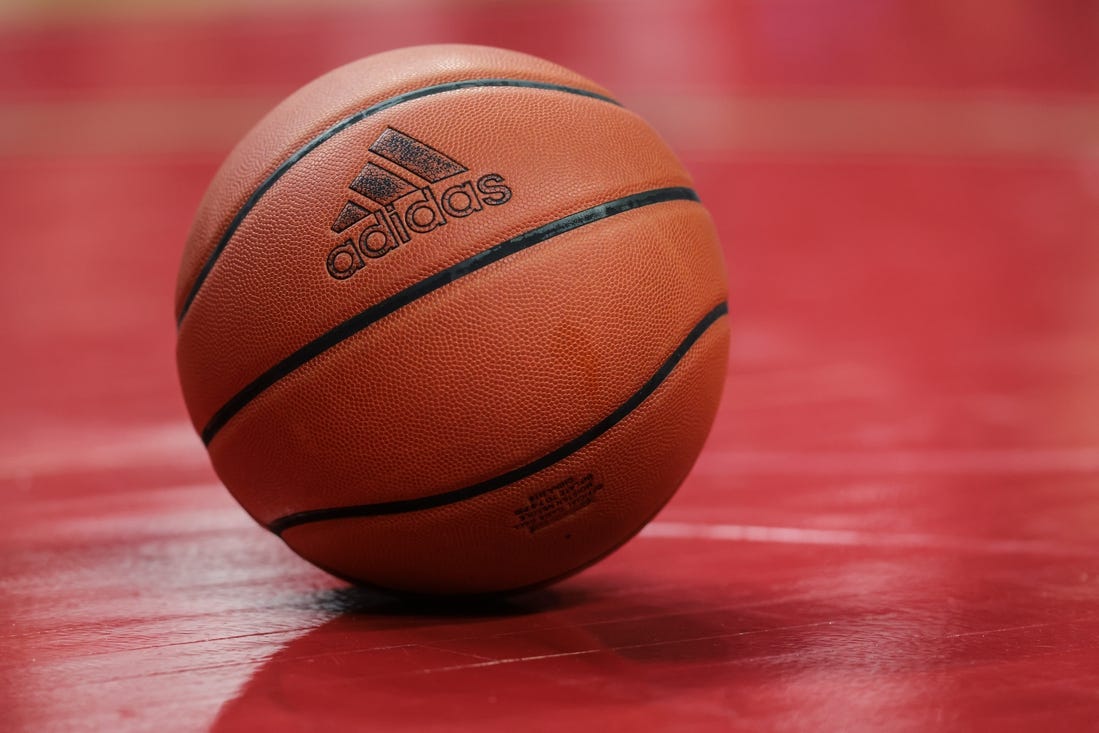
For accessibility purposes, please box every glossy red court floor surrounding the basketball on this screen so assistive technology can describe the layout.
[0,0,1099,732]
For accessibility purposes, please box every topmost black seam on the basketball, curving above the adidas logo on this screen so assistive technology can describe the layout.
[176,79,621,325]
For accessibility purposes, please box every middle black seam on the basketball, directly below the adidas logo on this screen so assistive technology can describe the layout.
[202,187,699,445]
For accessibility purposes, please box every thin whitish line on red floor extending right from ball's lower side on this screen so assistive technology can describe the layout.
[641,522,1099,557]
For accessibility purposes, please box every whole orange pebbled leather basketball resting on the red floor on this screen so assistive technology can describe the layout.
[176,45,729,593]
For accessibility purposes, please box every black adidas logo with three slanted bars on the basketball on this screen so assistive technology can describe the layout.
[328,127,511,280]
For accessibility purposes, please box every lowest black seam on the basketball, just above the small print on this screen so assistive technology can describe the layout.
[267,301,729,534]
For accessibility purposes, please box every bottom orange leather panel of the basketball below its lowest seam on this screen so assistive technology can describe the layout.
[284,319,729,595]
